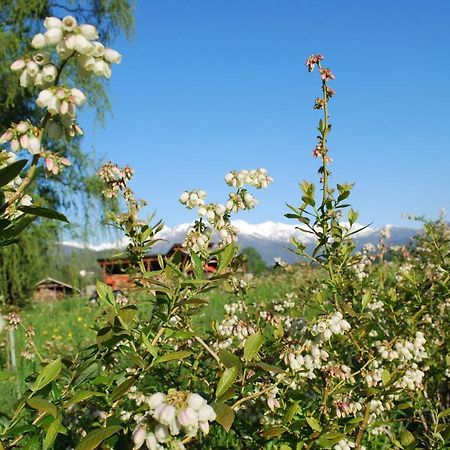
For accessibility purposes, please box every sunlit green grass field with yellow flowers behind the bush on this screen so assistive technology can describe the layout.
[0,272,310,414]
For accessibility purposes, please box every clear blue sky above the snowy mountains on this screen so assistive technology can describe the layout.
[81,0,450,226]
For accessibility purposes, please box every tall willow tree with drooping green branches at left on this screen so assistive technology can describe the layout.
[0,0,134,303]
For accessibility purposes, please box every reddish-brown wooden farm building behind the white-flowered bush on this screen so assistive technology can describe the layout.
[97,244,217,289]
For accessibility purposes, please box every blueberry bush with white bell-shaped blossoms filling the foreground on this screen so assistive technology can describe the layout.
[0,17,450,450]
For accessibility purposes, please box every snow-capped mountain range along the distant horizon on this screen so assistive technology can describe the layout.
[63,220,420,264]
